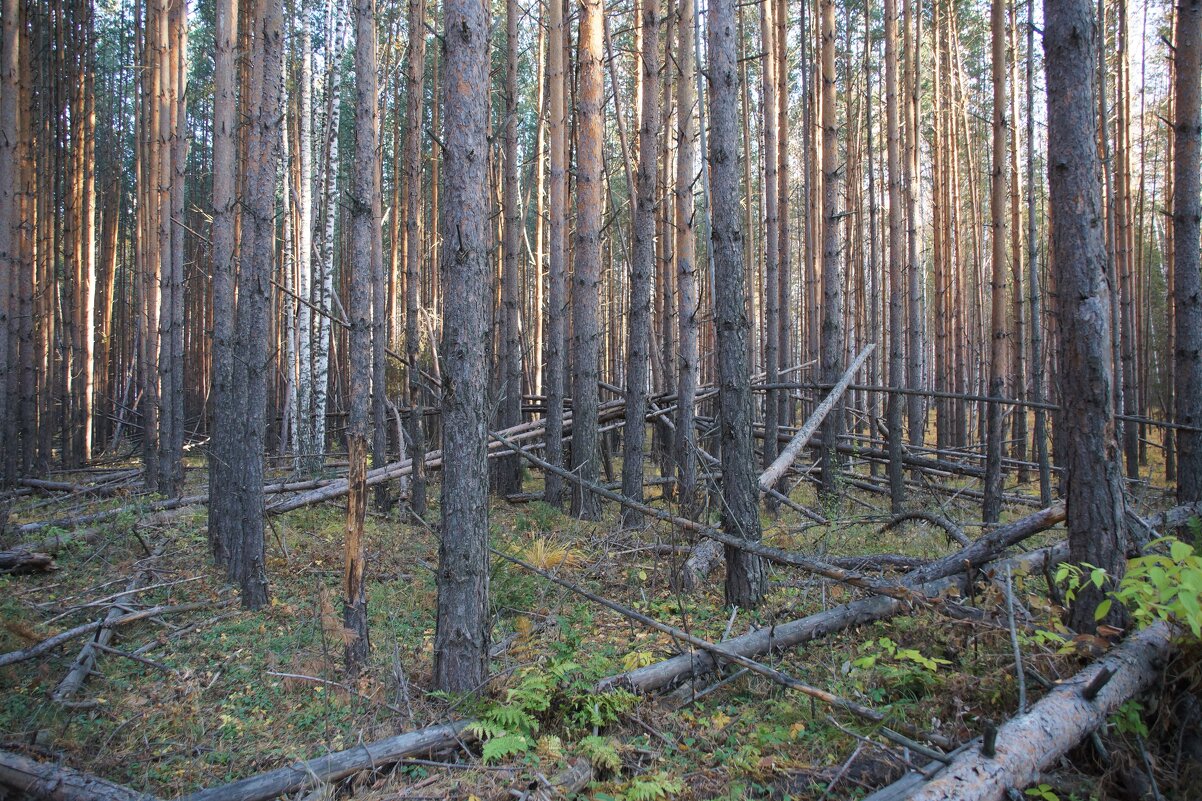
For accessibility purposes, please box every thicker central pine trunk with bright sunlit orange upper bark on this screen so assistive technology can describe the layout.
[571,0,605,520]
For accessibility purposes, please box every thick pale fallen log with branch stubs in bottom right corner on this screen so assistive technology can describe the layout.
[870,621,1172,801]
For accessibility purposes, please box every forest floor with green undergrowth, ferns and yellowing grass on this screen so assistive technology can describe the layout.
[0,445,1194,801]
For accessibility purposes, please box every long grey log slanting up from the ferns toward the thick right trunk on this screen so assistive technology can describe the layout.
[599,545,1069,693]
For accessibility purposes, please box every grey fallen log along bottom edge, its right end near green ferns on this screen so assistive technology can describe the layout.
[182,720,471,801]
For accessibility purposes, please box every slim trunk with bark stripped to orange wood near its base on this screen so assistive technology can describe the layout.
[343,0,385,677]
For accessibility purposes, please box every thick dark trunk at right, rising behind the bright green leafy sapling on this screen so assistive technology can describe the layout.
[1043,0,1126,631]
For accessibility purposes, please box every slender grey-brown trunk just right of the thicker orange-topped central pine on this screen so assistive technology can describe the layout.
[621,0,660,526]
